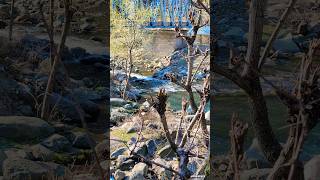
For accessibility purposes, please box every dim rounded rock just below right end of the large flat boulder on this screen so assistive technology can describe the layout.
[41,134,72,152]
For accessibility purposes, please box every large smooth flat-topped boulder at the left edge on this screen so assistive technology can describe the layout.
[0,116,54,141]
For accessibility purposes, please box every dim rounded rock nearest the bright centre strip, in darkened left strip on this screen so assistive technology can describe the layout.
[72,132,95,149]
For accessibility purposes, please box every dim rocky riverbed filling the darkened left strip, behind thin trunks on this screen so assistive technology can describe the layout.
[0,0,109,179]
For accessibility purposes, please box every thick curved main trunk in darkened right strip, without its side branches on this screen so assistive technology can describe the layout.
[242,0,281,163]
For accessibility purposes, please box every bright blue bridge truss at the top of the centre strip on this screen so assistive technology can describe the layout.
[112,0,191,28]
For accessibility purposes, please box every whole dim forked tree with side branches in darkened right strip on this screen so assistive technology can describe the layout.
[211,0,304,163]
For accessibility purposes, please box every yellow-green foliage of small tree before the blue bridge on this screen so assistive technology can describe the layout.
[110,0,151,67]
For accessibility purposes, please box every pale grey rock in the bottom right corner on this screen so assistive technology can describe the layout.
[303,155,320,180]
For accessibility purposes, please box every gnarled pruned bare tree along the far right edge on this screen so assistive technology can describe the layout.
[268,39,320,180]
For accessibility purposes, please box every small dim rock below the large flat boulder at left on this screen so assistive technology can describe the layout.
[31,144,54,161]
